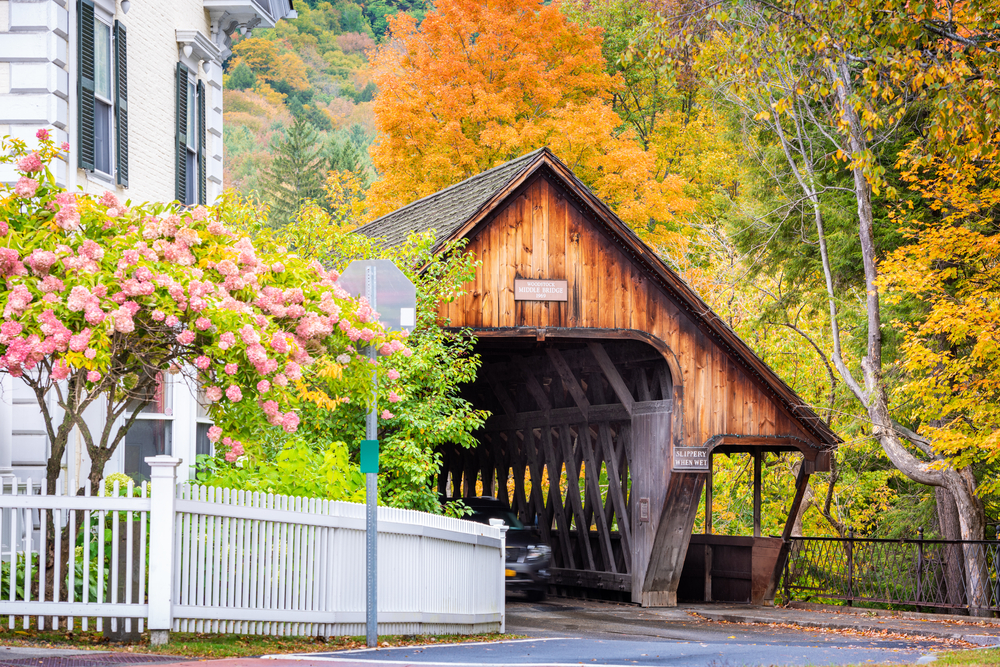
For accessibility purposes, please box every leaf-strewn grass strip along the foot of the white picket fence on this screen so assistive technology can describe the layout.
[0,628,522,658]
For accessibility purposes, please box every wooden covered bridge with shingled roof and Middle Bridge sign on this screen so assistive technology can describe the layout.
[359,149,837,606]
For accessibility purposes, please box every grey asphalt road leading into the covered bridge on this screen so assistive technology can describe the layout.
[262,598,955,667]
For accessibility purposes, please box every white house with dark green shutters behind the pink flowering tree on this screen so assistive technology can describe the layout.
[0,0,295,493]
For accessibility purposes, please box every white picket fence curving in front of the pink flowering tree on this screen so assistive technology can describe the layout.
[0,457,506,636]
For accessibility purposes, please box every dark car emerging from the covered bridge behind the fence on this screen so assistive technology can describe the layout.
[462,498,552,600]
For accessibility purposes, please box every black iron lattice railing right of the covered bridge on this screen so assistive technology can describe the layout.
[782,531,1000,612]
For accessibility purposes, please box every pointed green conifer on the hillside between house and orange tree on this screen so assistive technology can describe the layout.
[264,117,326,226]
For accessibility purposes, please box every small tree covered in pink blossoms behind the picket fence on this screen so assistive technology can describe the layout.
[0,130,408,493]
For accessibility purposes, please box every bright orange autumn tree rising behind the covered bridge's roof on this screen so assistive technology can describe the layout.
[369,0,694,251]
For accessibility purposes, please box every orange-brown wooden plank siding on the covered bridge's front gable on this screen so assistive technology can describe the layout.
[440,173,819,448]
